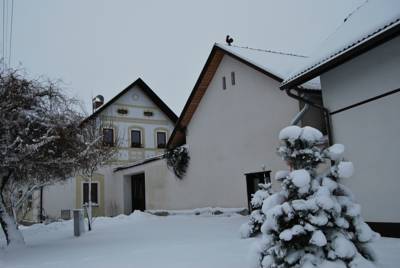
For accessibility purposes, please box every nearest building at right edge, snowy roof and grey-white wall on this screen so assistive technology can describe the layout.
[281,0,400,237]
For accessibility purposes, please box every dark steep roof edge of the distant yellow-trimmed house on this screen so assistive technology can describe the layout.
[83,78,178,123]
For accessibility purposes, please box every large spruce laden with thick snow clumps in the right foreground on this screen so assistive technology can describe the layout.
[255,126,379,268]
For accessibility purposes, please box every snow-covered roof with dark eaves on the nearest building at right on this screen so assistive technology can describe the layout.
[281,0,400,88]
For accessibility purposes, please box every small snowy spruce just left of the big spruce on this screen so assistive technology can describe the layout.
[240,183,272,238]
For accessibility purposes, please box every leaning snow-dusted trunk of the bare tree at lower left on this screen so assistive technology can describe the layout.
[0,193,25,247]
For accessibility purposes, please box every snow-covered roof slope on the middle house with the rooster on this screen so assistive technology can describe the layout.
[215,43,321,89]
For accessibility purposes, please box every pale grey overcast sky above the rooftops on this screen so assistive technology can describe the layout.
[3,0,365,115]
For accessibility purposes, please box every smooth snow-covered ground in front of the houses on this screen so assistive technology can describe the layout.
[0,213,400,268]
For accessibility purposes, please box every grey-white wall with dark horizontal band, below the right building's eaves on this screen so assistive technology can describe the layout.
[321,37,400,222]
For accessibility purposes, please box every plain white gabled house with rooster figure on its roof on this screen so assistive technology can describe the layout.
[114,44,324,213]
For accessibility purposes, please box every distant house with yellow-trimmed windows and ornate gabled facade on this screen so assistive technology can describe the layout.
[39,78,177,218]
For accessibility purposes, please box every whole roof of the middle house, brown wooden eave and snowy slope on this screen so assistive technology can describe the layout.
[167,44,320,148]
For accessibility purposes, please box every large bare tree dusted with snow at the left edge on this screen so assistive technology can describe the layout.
[0,70,95,246]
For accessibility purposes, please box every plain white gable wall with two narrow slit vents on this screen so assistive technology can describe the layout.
[185,56,299,207]
